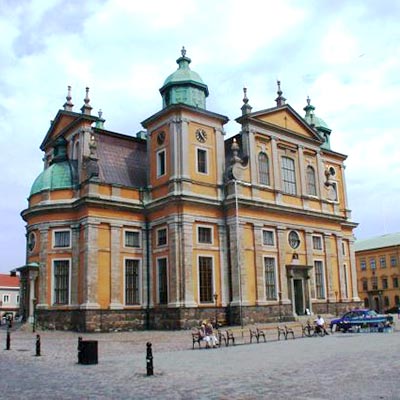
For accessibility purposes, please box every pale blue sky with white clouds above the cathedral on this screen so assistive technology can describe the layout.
[0,0,400,272]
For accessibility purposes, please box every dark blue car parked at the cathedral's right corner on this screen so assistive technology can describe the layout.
[330,309,393,332]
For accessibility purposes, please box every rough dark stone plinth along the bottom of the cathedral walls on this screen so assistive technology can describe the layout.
[36,302,361,332]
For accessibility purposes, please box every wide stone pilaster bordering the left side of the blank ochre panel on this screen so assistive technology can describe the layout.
[81,222,100,310]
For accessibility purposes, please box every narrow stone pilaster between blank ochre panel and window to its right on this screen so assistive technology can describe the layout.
[110,224,122,310]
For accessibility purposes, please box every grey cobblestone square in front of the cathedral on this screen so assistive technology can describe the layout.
[0,329,400,400]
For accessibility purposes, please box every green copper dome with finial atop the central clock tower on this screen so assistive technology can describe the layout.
[160,47,208,109]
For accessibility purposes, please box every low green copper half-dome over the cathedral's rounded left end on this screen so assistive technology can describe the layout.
[30,161,73,196]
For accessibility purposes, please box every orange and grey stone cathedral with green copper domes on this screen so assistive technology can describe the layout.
[19,49,360,331]
